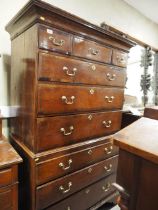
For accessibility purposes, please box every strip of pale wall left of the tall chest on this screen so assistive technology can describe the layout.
[0,0,27,106]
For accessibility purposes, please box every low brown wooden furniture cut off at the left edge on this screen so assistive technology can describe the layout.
[0,116,22,210]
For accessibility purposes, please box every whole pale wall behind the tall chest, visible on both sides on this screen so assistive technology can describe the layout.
[0,0,158,133]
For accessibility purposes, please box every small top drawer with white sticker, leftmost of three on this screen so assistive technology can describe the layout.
[39,26,72,54]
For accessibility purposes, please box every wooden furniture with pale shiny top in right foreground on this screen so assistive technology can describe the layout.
[114,116,158,210]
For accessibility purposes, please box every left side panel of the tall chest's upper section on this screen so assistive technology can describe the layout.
[10,25,37,150]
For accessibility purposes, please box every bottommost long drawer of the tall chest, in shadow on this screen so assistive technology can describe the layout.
[46,175,116,210]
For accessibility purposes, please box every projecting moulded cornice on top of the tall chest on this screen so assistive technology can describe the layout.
[6,0,134,51]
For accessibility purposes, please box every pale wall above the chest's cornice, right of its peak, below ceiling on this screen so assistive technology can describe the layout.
[44,0,158,49]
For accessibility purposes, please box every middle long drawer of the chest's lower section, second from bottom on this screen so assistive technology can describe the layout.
[36,156,118,210]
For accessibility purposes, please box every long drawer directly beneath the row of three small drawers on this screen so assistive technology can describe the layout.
[38,52,126,87]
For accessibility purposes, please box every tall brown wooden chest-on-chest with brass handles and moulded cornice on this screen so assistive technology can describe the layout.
[6,0,133,210]
